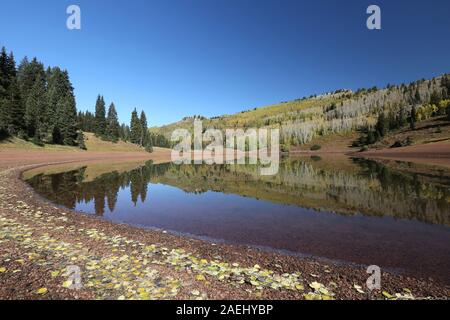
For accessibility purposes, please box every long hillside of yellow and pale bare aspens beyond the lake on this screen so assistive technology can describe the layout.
[150,75,450,149]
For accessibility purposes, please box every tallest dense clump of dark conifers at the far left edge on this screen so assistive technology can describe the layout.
[0,47,85,148]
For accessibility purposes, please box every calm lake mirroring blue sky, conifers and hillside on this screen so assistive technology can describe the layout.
[24,156,450,283]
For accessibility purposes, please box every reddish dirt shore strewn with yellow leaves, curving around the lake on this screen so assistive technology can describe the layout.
[0,151,450,299]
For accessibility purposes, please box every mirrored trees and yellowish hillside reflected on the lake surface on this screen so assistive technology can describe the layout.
[28,159,450,225]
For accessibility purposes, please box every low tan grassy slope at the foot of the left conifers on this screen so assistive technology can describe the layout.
[0,132,151,152]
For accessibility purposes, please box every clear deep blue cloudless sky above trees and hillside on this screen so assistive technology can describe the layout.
[0,0,450,126]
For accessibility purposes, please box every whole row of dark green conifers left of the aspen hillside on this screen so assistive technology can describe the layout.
[0,47,170,151]
